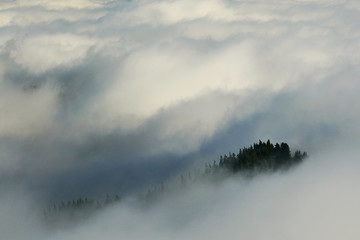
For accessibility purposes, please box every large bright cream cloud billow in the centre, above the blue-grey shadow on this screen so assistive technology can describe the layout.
[85,42,280,136]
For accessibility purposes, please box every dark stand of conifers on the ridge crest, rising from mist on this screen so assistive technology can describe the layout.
[176,140,307,188]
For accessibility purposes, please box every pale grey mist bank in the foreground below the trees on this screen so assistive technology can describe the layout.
[1,149,360,239]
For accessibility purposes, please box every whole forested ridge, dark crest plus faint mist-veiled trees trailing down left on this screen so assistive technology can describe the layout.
[44,140,307,224]
